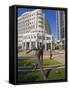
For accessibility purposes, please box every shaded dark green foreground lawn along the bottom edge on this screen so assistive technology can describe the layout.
[18,68,65,82]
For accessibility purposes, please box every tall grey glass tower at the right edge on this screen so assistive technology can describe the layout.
[57,11,65,48]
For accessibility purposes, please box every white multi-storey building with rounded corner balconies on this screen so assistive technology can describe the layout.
[18,9,52,49]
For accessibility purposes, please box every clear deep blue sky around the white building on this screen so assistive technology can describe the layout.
[18,8,56,38]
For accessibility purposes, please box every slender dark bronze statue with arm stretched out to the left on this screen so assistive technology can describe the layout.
[27,45,46,80]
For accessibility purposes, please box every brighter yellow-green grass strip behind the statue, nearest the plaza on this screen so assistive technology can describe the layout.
[17,59,61,66]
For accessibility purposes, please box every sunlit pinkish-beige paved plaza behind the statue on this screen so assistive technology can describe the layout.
[18,50,65,64]
